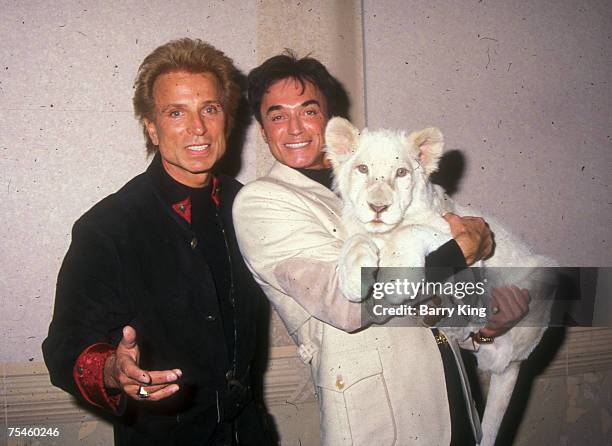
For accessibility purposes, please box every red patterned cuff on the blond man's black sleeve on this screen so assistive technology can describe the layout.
[72,343,121,413]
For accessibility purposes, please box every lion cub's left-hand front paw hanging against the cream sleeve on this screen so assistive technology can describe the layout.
[338,234,379,302]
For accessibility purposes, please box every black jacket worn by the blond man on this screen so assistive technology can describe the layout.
[43,157,265,444]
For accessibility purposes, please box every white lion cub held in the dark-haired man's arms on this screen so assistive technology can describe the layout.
[325,118,554,445]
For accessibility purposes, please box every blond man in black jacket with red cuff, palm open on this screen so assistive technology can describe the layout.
[43,39,266,446]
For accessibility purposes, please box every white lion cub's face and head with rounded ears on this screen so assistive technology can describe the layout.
[325,118,443,233]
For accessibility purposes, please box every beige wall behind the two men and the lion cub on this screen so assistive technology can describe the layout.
[0,0,612,445]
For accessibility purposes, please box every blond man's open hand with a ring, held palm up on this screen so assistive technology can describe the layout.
[104,325,182,401]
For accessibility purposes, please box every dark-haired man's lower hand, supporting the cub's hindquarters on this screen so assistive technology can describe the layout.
[479,285,531,338]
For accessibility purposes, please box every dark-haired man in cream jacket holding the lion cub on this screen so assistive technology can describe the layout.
[234,54,528,446]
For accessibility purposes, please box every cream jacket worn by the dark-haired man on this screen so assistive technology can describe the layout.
[233,162,478,446]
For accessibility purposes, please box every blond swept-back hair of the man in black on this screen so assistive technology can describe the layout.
[133,38,240,154]
